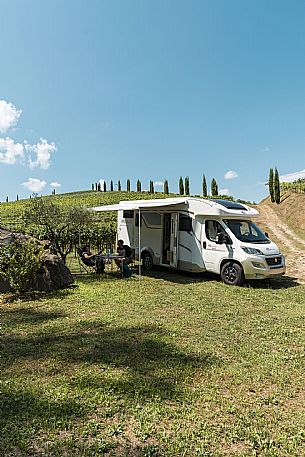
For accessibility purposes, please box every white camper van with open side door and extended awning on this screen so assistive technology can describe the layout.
[93,197,285,285]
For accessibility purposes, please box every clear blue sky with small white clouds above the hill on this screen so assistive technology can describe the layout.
[0,0,305,201]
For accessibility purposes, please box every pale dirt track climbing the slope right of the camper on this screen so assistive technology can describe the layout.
[257,203,305,283]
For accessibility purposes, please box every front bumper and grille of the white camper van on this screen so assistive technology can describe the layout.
[242,254,286,279]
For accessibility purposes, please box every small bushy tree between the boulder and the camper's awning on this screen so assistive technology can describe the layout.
[24,197,93,263]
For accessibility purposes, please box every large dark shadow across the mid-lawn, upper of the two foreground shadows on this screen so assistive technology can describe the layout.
[2,322,216,399]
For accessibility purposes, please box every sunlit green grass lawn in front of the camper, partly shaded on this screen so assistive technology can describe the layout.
[0,271,305,457]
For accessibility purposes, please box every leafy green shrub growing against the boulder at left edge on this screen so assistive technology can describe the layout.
[0,240,44,292]
